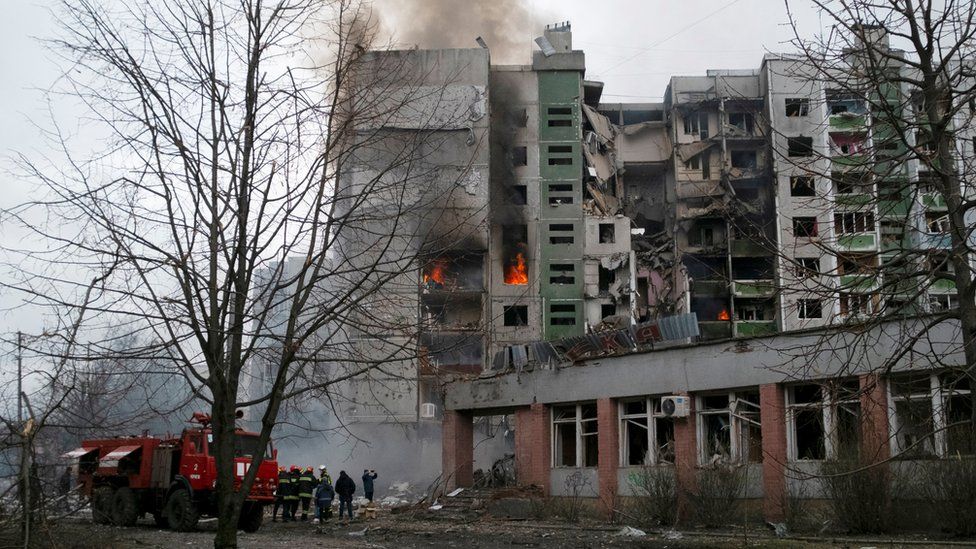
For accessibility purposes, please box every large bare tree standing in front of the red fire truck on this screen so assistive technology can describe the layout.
[6,0,487,547]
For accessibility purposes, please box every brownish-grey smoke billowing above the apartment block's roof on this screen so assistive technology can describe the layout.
[373,0,547,64]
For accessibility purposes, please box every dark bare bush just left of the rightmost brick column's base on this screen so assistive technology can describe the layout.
[820,458,891,534]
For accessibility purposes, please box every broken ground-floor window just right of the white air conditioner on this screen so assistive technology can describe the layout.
[697,391,762,465]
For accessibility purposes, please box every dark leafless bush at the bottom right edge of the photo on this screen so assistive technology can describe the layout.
[921,457,976,536]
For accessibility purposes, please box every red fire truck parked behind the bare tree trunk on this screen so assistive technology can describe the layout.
[65,412,278,532]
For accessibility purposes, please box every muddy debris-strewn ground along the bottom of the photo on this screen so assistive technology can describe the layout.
[11,515,976,549]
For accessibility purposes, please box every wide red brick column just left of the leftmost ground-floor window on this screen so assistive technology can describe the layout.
[515,404,552,495]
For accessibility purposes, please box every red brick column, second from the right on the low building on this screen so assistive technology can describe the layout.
[759,383,786,522]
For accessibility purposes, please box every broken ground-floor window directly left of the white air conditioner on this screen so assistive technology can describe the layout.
[620,398,674,467]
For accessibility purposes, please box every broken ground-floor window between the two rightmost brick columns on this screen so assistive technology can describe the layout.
[786,379,861,461]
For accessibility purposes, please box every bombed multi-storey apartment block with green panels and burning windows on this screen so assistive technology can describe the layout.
[292,23,968,488]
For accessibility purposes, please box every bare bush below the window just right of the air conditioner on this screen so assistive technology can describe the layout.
[688,465,746,527]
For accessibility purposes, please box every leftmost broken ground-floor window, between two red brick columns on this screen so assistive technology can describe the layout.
[552,403,599,467]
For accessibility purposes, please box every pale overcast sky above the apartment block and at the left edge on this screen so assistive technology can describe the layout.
[0,0,820,333]
